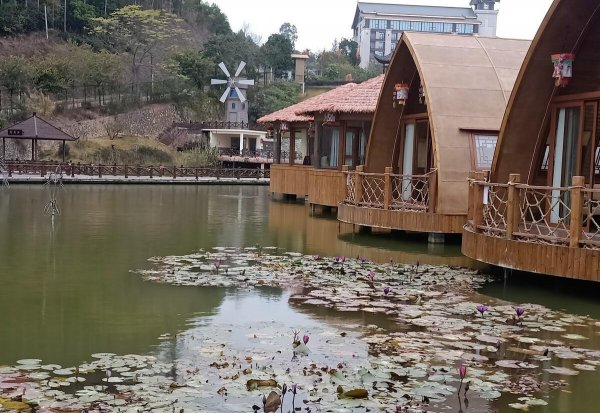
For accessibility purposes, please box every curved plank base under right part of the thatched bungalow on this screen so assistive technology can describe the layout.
[308,169,346,207]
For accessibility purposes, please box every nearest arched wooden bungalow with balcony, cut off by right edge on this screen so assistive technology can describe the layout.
[462,0,600,281]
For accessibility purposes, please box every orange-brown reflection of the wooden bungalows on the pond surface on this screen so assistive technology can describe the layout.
[269,201,481,268]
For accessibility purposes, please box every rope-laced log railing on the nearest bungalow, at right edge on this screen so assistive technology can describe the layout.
[467,174,600,249]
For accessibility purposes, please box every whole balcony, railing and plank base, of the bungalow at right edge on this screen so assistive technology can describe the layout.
[462,174,600,281]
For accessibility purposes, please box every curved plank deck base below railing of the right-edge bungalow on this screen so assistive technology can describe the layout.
[462,228,600,281]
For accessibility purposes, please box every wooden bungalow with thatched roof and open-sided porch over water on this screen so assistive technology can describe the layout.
[258,75,383,207]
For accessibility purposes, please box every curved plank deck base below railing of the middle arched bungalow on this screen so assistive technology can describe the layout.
[338,204,466,234]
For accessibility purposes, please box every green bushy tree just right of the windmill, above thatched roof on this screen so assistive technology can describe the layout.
[248,81,300,123]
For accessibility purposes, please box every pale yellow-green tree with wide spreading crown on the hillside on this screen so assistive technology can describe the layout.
[94,6,187,86]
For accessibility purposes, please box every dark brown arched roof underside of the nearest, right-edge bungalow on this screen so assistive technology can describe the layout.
[492,0,600,182]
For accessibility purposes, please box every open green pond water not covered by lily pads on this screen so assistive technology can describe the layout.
[0,185,600,413]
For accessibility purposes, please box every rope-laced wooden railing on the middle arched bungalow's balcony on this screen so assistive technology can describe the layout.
[344,166,437,212]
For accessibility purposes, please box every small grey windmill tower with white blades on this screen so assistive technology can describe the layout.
[210,61,254,123]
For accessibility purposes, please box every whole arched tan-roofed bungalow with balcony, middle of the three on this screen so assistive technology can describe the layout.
[338,32,530,242]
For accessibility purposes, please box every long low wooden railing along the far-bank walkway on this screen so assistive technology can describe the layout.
[6,161,270,179]
